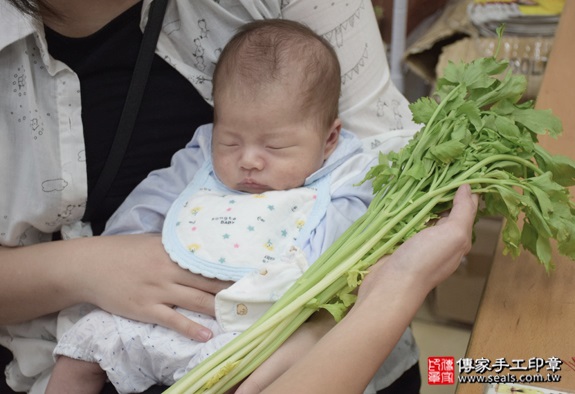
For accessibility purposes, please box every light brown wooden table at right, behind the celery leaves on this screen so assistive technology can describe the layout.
[456,0,575,394]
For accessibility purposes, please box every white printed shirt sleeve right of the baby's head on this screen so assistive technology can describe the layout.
[282,0,418,139]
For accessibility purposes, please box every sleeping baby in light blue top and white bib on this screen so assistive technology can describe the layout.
[47,20,375,394]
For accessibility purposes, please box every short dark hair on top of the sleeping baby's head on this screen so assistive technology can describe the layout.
[213,19,341,127]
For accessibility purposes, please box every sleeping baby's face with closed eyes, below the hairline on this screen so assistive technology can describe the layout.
[212,85,339,193]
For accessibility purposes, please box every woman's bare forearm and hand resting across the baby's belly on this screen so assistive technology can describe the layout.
[0,234,234,341]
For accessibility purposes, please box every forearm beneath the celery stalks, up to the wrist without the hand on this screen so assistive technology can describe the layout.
[264,264,426,394]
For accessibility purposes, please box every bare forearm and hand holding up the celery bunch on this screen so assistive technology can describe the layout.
[260,185,477,394]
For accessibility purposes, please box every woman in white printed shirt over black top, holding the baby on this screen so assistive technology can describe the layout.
[0,0,424,393]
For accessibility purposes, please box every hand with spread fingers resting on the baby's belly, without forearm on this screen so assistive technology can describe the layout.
[85,234,234,341]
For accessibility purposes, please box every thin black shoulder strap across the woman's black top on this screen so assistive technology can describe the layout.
[82,0,167,222]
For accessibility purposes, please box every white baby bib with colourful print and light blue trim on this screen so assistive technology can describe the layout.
[163,162,329,281]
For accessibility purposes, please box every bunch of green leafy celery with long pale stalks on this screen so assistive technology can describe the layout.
[167,48,575,393]
